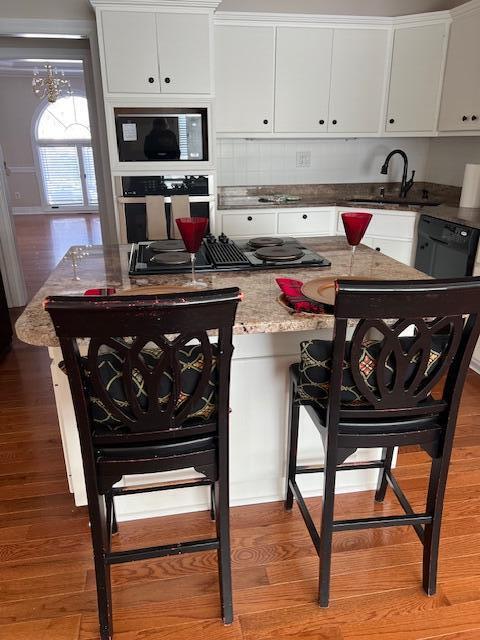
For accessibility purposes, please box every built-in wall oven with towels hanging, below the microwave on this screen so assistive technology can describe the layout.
[115,175,214,244]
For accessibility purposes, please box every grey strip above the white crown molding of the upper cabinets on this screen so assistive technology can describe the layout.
[218,0,466,16]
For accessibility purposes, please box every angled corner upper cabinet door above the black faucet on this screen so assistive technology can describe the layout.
[386,24,445,131]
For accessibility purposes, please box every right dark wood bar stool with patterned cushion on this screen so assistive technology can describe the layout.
[285,278,480,607]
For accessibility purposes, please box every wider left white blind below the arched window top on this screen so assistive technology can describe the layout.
[38,146,83,206]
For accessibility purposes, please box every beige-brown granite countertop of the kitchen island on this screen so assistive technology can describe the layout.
[16,236,425,347]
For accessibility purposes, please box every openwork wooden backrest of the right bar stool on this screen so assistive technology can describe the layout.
[329,278,480,424]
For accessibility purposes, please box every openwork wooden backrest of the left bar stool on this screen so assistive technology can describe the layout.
[44,288,240,443]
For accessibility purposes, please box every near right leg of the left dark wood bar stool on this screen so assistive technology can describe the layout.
[214,464,233,624]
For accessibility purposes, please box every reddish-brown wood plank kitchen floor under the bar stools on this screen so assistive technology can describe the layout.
[0,216,480,640]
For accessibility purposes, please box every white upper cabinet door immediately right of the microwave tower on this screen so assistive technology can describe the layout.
[215,25,274,133]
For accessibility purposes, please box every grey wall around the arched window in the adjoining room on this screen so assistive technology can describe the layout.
[0,74,85,210]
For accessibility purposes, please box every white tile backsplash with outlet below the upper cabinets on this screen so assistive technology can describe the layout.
[217,138,429,186]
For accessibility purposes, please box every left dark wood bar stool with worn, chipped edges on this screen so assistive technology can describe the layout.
[45,288,240,640]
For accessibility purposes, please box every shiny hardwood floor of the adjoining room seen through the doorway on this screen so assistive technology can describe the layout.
[14,213,102,298]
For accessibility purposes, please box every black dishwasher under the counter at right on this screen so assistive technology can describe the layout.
[415,215,479,278]
